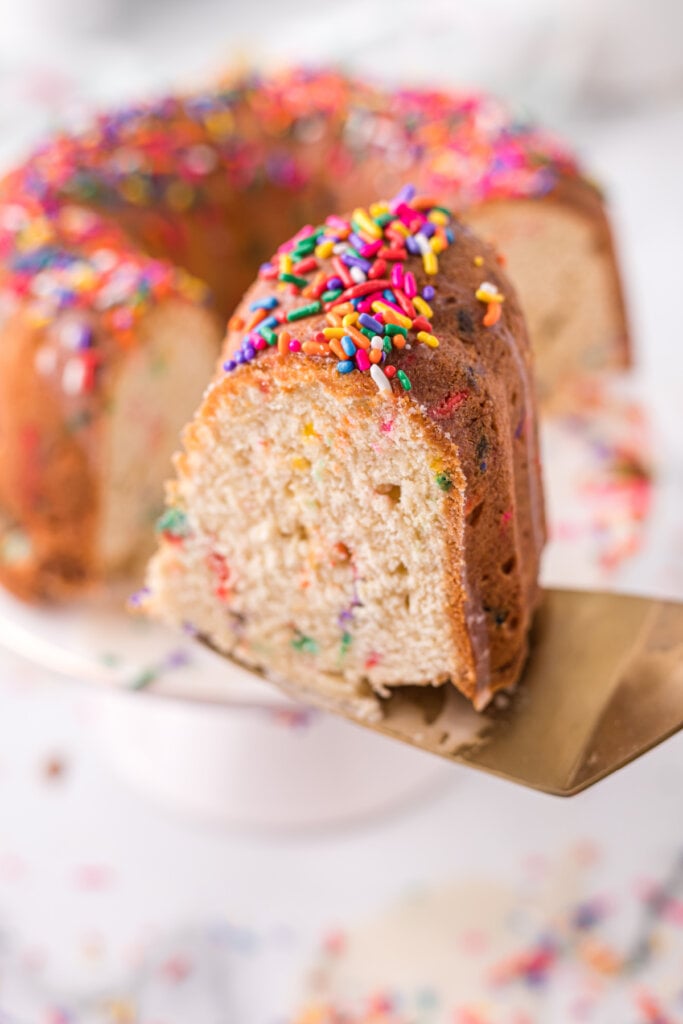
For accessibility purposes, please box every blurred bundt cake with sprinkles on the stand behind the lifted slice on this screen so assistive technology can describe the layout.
[0,71,627,597]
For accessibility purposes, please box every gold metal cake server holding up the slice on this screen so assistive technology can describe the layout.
[270,590,683,797]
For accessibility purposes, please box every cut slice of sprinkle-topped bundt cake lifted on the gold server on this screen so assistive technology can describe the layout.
[140,187,545,713]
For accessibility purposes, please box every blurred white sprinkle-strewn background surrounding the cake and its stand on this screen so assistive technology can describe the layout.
[0,0,683,1024]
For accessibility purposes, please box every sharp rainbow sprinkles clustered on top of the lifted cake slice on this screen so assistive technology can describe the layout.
[223,185,456,394]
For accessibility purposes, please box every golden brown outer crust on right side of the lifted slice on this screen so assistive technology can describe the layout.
[412,232,545,695]
